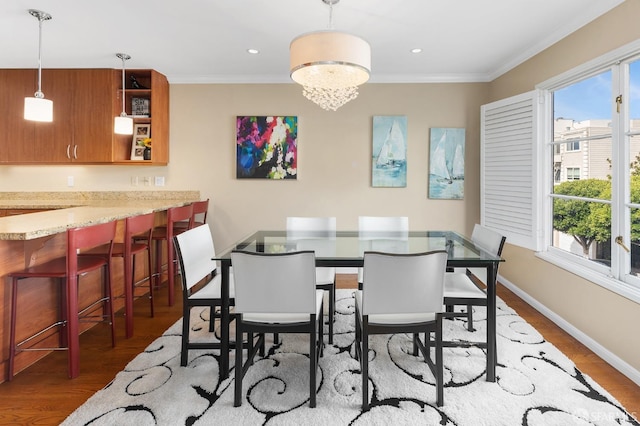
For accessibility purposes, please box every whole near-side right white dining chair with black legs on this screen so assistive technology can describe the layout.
[355,250,447,411]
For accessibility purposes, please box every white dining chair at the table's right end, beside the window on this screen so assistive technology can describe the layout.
[444,224,506,331]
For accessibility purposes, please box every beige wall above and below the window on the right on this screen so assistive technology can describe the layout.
[490,0,640,375]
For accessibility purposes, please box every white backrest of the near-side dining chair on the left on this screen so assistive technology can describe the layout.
[231,251,316,314]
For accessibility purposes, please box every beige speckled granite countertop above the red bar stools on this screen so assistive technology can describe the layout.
[0,191,200,240]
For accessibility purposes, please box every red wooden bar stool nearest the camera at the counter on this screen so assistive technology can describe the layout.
[8,221,116,380]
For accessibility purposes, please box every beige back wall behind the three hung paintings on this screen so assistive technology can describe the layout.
[171,84,487,247]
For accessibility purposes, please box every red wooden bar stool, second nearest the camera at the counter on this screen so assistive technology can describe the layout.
[83,213,155,339]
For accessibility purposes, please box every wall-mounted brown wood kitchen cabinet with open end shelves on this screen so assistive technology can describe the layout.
[0,69,169,165]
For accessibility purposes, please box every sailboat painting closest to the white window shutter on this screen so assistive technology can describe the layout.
[429,127,465,200]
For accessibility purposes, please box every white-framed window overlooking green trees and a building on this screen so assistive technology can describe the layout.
[538,45,640,295]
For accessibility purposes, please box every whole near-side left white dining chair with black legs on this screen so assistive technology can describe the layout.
[231,251,324,408]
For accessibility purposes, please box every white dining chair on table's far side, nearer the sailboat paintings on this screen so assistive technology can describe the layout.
[358,216,409,289]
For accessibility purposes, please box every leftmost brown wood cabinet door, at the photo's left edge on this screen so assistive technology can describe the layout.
[0,69,37,163]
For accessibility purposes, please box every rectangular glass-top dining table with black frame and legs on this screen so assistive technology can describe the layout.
[214,230,503,382]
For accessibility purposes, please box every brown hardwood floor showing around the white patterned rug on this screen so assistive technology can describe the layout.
[0,275,640,425]
